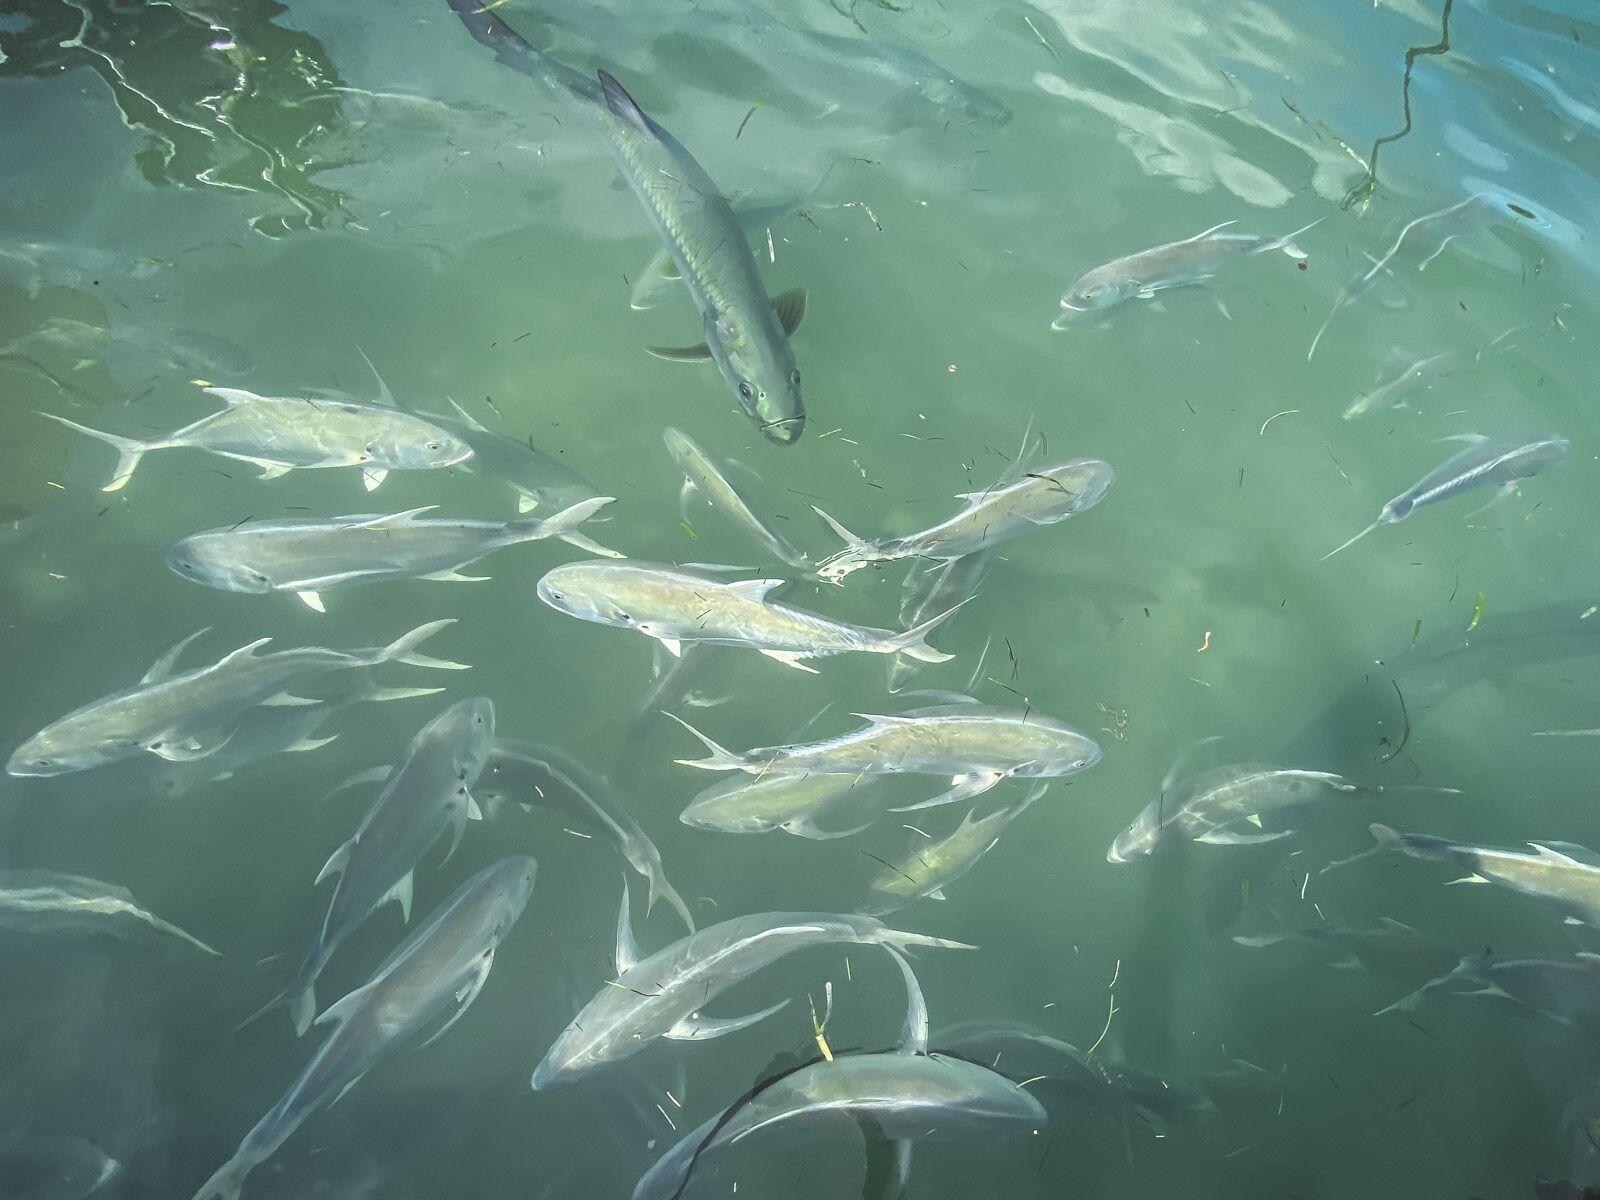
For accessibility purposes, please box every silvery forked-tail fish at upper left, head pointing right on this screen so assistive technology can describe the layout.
[40,387,472,491]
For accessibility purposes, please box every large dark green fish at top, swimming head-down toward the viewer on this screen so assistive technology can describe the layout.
[450,0,806,445]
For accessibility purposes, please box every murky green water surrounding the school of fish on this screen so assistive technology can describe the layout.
[0,0,1600,1200]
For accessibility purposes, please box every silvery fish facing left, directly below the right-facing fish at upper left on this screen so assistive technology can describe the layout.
[162,496,621,613]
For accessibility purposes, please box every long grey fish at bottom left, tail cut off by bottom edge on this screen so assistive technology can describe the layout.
[194,854,538,1200]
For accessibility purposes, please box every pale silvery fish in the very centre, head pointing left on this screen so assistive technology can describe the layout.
[538,560,954,675]
